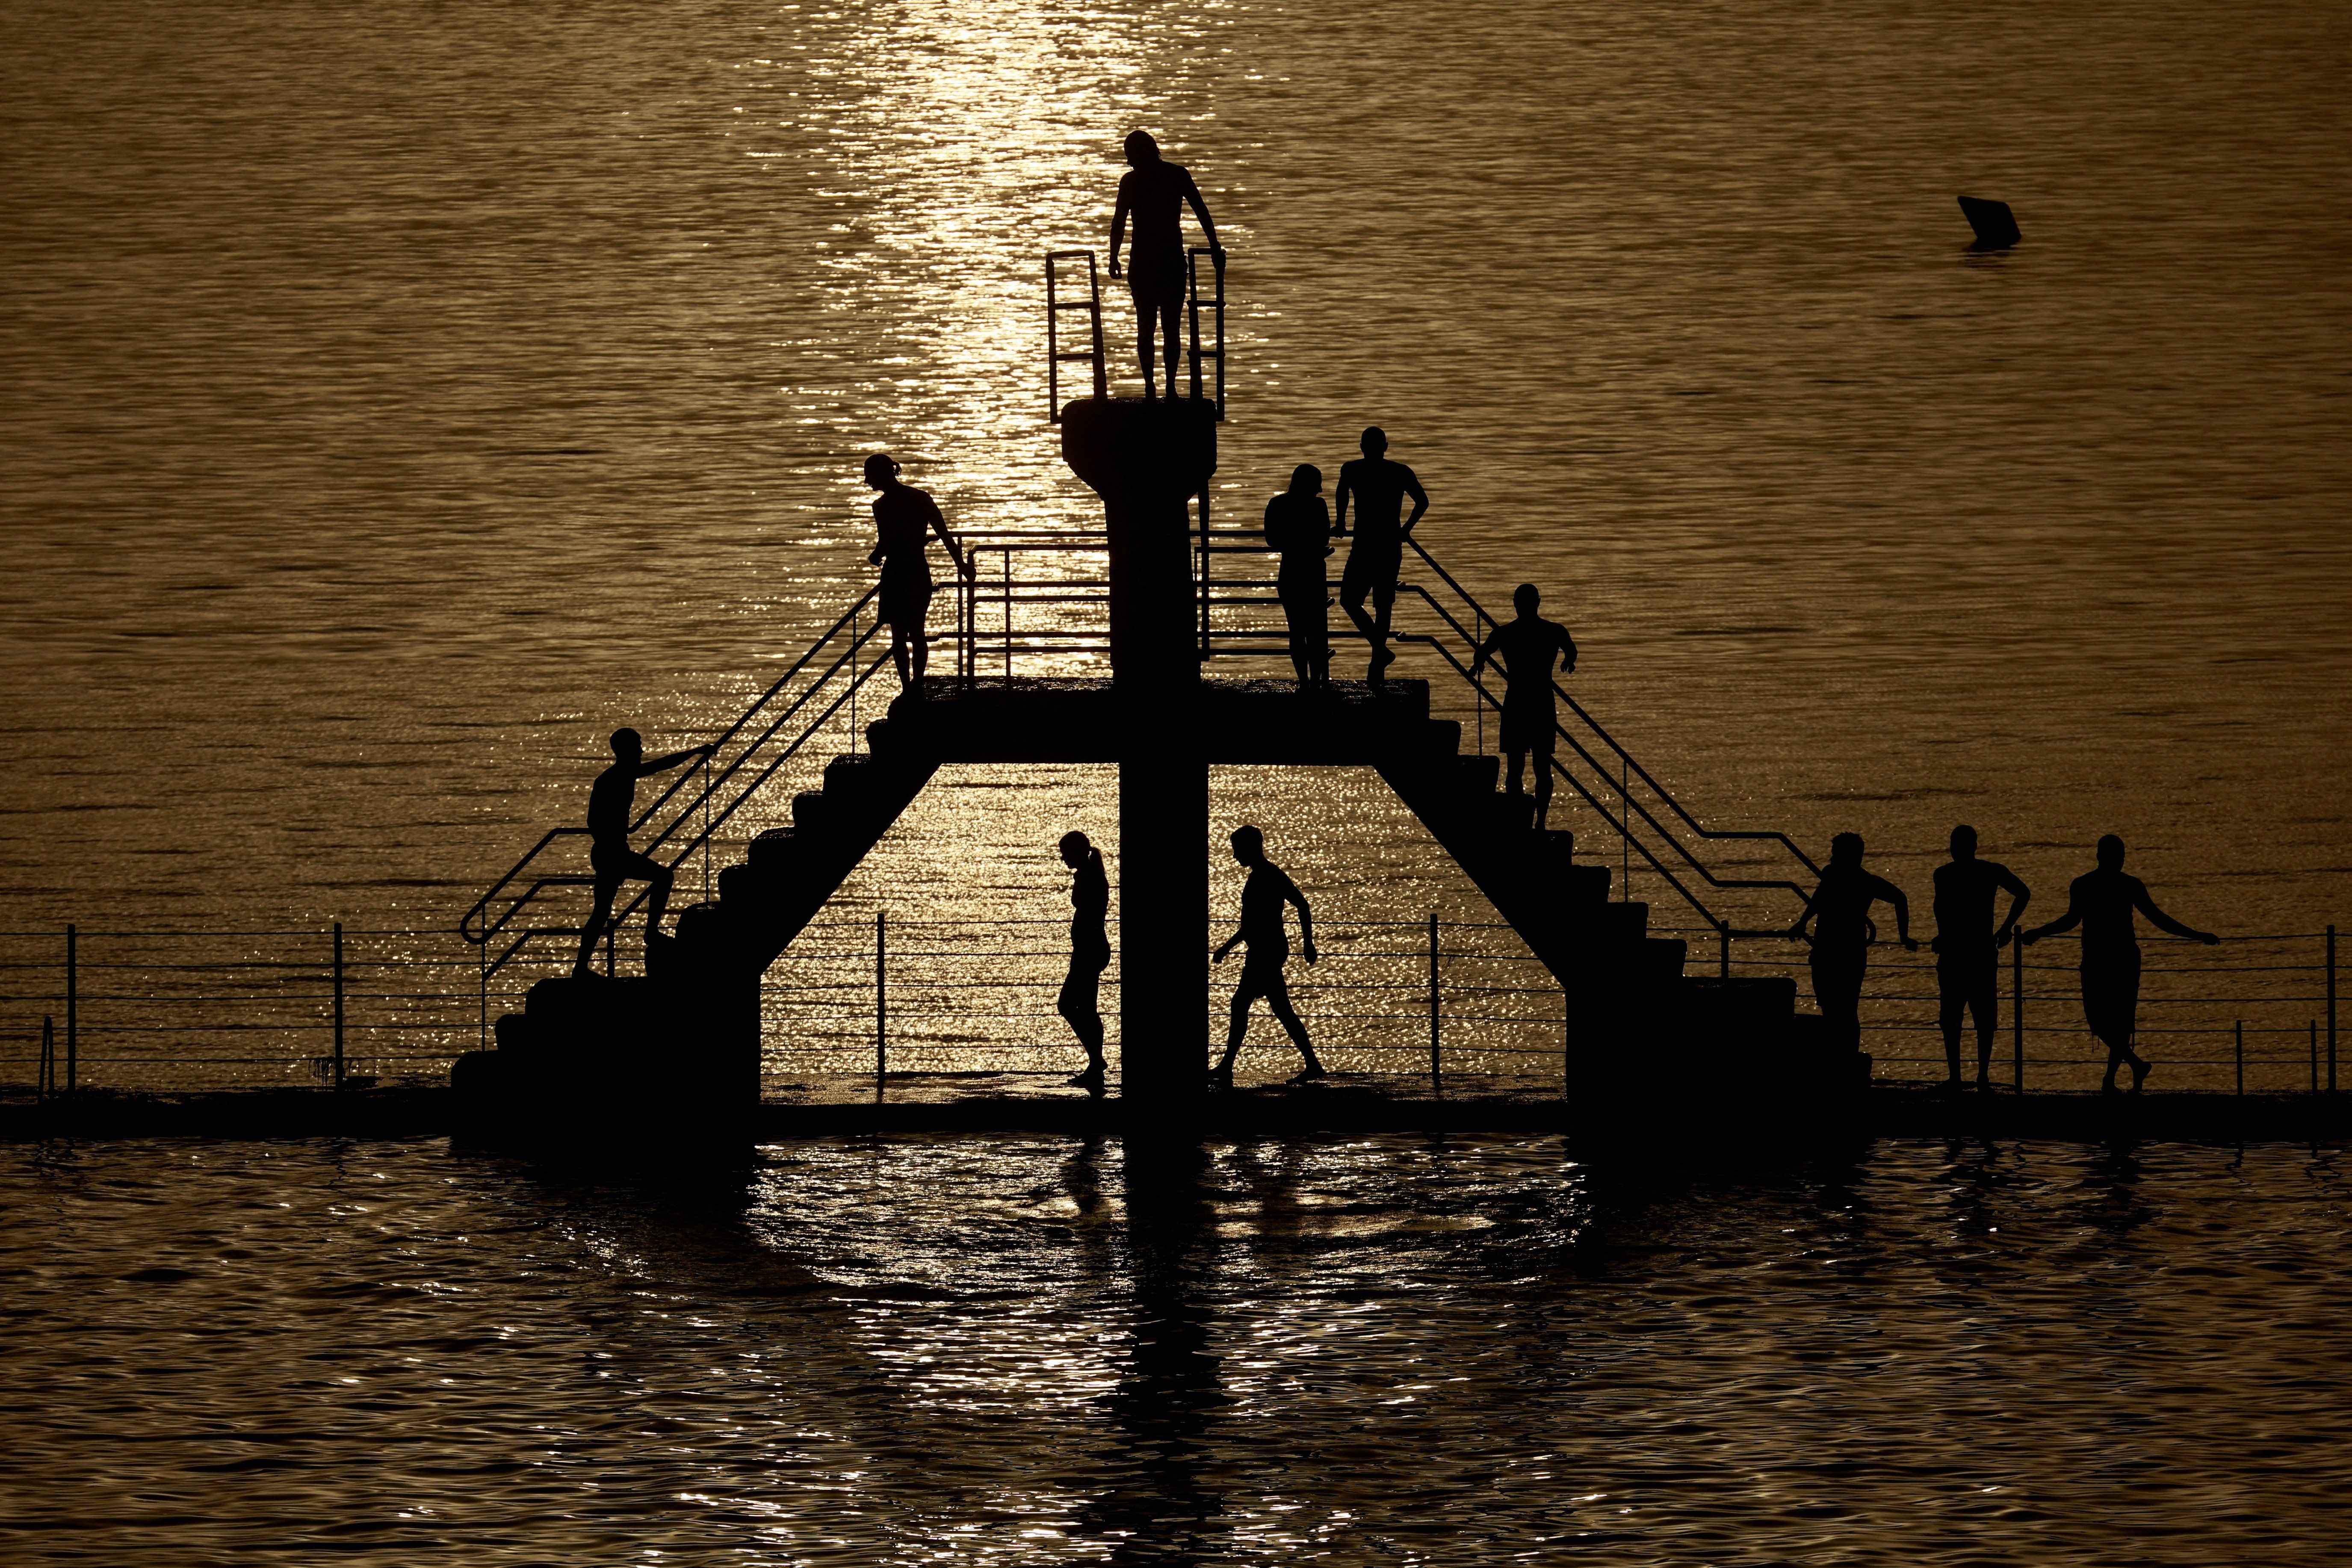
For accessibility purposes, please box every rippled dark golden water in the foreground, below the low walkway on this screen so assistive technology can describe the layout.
[0,1138,2352,1568]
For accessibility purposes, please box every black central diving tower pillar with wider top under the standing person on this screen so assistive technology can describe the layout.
[1061,400,1216,1119]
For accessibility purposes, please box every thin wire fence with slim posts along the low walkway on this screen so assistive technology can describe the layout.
[0,912,2338,1098]
